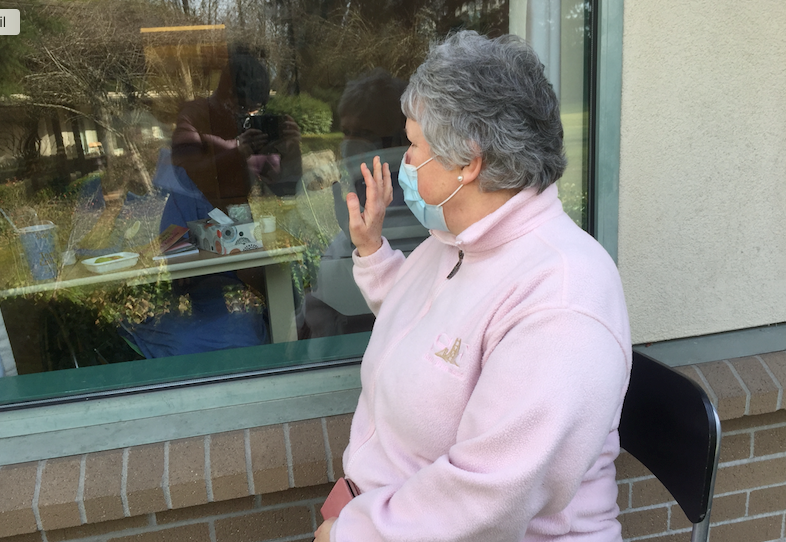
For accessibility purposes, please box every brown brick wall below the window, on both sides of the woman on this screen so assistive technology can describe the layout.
[0,352,786,542]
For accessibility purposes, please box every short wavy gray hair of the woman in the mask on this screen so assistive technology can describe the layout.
[401,31,567,192]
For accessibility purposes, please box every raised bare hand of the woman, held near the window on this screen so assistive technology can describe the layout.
[347,156,393,256]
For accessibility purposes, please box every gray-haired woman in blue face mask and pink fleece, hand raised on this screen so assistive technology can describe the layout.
[316,32,631,542]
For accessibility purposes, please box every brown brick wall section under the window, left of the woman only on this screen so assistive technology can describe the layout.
[0,422,352,542]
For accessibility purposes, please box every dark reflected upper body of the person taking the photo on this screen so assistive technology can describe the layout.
[172,49,302,207]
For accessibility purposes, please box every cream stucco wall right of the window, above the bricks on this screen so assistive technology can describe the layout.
[619,0,786,343]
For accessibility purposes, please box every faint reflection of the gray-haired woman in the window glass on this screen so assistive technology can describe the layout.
[299,68,428,338]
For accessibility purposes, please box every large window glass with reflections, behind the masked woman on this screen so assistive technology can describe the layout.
[0,0,590,404]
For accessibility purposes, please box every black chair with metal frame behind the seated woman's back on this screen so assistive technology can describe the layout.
[619,352,721,542]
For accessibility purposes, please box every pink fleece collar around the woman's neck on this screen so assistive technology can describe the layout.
[431,184,563,252]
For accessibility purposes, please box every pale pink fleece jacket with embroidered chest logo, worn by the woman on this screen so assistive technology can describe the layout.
[331,186,631,542]
